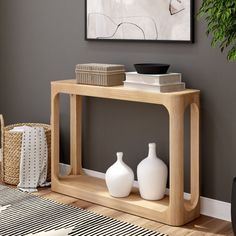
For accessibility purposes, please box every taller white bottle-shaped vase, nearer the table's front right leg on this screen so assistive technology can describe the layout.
[137,143,168,200]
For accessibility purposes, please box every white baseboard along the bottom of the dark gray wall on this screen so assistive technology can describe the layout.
[83,169,231,221]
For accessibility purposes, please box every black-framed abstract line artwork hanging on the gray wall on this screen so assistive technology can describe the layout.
[85,0,194,42]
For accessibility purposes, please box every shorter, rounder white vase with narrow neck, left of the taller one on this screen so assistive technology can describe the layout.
[105,152,134,197]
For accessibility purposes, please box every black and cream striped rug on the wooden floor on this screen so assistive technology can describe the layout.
[0,185,166,236]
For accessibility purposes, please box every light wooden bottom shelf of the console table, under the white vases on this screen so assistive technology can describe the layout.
[52,175,197,224]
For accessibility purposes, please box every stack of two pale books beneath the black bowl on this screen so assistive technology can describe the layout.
[124,72,185,93]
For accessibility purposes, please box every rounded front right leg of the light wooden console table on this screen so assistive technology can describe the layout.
[168,99,185,225]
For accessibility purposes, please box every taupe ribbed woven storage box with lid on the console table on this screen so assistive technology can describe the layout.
[75,63,125,86]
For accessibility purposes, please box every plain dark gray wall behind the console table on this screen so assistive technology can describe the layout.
[0,0,236,201]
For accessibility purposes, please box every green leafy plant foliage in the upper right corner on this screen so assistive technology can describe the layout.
[198,0,236,61]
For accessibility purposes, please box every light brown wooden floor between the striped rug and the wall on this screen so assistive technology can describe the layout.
[28,188,234,236]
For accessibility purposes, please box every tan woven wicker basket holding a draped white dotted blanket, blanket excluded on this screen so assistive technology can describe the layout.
[0,115,51,185]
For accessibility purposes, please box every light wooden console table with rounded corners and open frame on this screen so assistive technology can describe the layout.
[51,80,200,226]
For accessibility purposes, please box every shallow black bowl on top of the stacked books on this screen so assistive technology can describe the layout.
[134,63,170,74]
